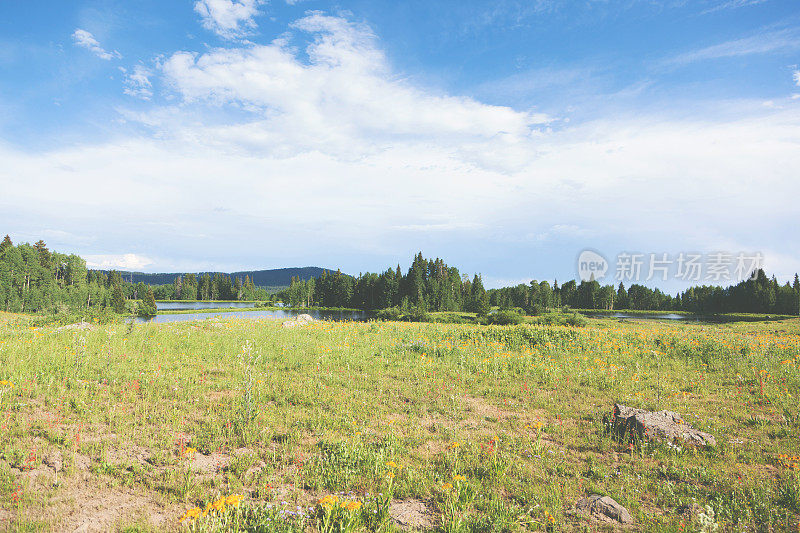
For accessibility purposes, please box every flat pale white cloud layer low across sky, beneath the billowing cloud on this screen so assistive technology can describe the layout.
[0,100,800,275]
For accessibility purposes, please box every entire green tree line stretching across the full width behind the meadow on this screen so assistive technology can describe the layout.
[0,235,800,315]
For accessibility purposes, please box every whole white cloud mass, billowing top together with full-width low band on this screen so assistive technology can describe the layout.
[0,13,800,278]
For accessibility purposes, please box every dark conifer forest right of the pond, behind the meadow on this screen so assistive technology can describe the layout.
[279,253,800,315]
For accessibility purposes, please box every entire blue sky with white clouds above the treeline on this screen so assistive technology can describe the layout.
[0,0,800,289]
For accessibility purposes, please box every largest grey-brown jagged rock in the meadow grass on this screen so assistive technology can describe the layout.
[614,404,717,446]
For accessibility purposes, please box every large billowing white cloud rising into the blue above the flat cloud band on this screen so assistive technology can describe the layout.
[162,13,549,166]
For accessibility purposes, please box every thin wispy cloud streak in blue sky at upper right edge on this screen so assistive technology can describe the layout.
[664,28,800,66]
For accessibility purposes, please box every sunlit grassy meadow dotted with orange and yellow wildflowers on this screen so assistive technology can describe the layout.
[0,315,800,532]
